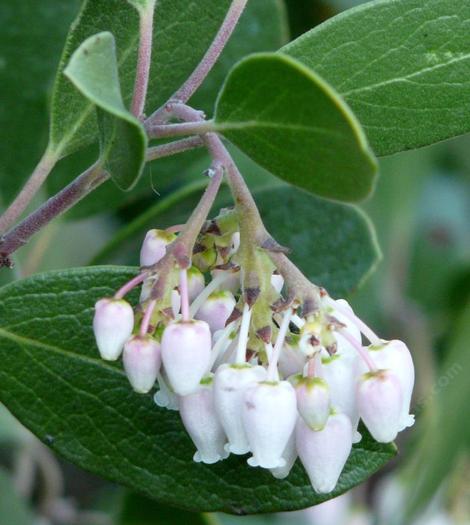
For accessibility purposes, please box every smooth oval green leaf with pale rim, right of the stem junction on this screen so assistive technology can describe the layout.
[215,53,376,200]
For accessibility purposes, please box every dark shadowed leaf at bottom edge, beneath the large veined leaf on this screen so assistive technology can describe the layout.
[117,493,218,525]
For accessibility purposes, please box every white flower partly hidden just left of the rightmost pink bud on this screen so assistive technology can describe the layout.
[319,349,361,443]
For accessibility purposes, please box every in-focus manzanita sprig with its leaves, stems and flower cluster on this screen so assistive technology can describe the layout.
[0,0,470,514]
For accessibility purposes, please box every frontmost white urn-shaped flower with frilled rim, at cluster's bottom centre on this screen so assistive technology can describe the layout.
[242,381,297,469]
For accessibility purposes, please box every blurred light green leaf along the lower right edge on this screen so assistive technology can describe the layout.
[406,298,470,522]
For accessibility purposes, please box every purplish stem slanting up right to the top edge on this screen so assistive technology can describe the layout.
[148,0,248,122]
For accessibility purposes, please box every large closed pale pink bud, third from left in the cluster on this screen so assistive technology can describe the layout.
[162,321,211,396]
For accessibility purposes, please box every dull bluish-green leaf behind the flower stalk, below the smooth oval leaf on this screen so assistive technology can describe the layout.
[255,187,380,297]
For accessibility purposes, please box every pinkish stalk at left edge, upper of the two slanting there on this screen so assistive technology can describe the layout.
[0,151,57,234]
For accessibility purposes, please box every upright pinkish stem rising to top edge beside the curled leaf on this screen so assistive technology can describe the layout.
[131,0,155,118]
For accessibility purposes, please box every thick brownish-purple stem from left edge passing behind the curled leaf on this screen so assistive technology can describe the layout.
[0,139,198,268]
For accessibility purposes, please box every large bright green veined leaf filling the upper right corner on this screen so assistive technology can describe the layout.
[282,0,470,155]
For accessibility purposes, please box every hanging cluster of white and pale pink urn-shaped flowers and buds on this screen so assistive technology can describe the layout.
[94,210,414,493]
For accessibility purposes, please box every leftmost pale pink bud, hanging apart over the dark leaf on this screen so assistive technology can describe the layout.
[93,298,134,361]
